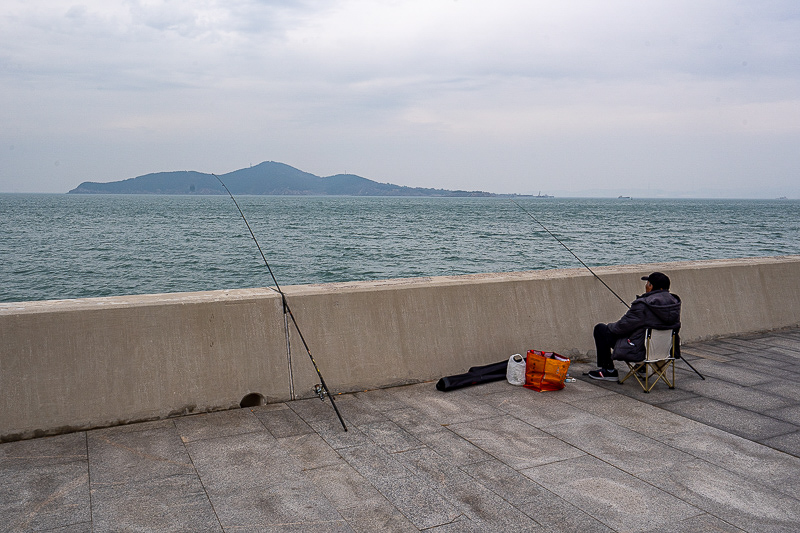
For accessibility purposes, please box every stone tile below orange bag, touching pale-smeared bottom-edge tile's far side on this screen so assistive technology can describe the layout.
[449,415,584,470]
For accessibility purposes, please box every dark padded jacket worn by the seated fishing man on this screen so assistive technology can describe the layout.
[608,289,681,361]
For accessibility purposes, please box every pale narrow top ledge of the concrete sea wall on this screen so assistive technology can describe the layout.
[0,255,800,316]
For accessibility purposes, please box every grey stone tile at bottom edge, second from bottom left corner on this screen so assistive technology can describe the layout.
[92,475,222,533]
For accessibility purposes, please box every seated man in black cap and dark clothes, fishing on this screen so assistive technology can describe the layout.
[588,272,681,381]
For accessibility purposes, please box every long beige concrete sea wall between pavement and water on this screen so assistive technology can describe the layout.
[0,256,800,441]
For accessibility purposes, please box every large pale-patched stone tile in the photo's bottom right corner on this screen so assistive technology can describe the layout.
[641,460,800,533]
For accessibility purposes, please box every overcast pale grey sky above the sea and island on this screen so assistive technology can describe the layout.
[0,0,800,198]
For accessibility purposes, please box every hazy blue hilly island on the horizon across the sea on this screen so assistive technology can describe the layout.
[67,161,526,197]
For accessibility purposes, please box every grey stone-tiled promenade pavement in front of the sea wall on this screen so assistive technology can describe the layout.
[0,329,800,533]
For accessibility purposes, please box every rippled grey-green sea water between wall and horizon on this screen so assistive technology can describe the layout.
[0,194,800,302]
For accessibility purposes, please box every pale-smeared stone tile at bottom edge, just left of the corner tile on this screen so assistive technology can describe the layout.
[522,456,701,531]
